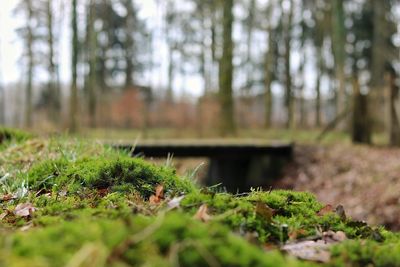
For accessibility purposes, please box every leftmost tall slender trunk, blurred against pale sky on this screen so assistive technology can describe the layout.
[25,0,34,128]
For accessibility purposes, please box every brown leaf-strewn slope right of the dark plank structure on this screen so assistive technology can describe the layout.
[276,144,400,230]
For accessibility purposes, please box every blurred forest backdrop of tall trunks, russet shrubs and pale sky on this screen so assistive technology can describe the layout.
[0,0,400,146]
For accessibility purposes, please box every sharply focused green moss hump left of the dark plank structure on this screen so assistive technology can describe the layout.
[28,156,194,198]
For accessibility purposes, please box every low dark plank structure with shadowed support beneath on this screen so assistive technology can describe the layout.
[113,140,294,192]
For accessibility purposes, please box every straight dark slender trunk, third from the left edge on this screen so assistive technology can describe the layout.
[69,0,79,133]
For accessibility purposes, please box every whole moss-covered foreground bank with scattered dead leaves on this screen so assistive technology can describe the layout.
[0,129,400,267]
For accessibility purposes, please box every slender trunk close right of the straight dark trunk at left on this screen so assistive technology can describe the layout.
[88,0,97,128]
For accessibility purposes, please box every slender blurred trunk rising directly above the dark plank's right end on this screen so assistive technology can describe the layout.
[285,0,294,129]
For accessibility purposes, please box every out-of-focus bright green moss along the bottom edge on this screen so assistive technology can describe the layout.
[2,212,309,266]
